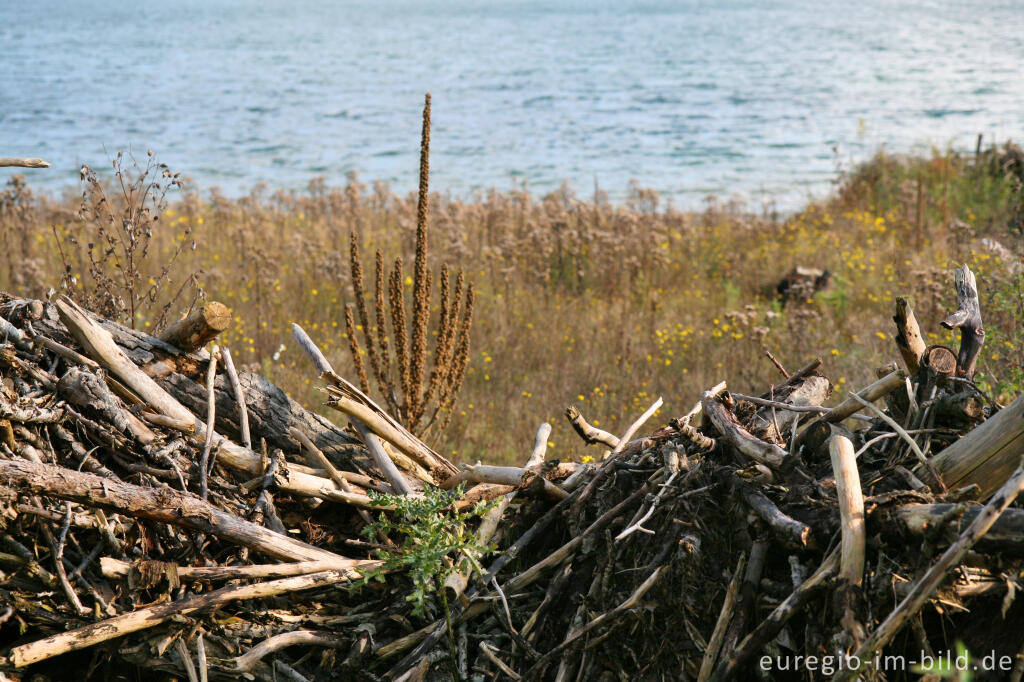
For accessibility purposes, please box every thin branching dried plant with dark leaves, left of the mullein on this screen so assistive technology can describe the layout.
[52,152,202,330]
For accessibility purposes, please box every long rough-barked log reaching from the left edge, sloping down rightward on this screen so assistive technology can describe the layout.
[0,460,351,568]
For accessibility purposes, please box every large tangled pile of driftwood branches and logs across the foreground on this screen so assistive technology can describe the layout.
[0,266,1024,681]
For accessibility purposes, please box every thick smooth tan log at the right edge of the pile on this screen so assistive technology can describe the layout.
[931,387,1024,495]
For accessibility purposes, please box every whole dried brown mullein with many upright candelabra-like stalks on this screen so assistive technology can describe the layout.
[345,94,474,435]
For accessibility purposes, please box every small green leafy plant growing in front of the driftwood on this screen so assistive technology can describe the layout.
[362,485,495,615]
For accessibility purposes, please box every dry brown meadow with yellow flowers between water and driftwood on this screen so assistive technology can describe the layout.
[0,143,1024,462]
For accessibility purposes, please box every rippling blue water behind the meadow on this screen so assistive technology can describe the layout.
[0,0,1024,207]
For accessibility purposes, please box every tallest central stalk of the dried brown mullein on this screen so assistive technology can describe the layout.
[406,92,430,428]
